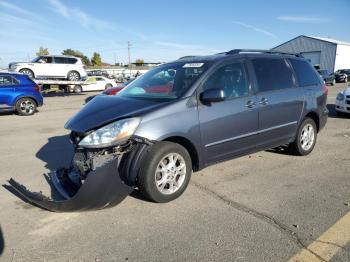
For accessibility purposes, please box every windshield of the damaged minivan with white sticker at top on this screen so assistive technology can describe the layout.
[119,62,208,99]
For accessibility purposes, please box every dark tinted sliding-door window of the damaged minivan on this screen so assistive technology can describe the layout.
[252,58,294,92]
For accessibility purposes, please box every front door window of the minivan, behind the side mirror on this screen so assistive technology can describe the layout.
[203,62,249,99]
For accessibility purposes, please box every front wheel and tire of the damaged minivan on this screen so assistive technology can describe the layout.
[138,142,192,203]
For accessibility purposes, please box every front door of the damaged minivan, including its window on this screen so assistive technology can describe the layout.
[198,60,258,164]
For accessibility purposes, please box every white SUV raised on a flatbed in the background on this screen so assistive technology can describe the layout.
[9,55,87,81]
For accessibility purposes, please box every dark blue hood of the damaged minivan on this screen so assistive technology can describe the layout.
[65,95,169,133]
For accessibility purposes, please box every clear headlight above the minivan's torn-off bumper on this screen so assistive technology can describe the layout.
[79,117,141,148]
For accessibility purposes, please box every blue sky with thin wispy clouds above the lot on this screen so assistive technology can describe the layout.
[0,0,350,67]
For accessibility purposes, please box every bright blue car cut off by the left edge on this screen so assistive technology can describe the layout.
[0,72,44,116]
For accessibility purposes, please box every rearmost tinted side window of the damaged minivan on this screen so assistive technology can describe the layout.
[289,59,320,86]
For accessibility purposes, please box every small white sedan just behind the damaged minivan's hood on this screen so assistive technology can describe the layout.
[73,76,117,93]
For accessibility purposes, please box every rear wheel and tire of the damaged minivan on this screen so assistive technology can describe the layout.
[289,118,317,156]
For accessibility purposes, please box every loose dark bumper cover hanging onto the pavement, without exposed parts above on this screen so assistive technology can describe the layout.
[9,158,133,212]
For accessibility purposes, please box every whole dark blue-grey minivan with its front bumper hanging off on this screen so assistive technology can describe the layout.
[9,49,328,212]
